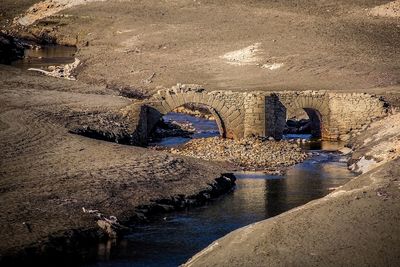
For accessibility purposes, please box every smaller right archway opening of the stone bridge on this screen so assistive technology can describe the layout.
[284,108,322,139]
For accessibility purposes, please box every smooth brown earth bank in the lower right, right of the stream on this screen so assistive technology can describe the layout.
[184,114,400,266]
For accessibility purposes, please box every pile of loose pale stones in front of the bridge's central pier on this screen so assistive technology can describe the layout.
[164,137,307,173]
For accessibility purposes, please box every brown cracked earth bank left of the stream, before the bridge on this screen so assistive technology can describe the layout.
[0,65,234,261]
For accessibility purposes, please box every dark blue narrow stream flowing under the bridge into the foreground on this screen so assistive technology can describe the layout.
[87,114,353,266]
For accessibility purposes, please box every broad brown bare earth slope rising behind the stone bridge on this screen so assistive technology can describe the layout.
[3,0,400,94]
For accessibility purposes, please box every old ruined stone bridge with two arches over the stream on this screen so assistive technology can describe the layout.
[126,84,387,146]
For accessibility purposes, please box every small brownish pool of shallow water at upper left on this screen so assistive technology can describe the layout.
[11,45,76,69]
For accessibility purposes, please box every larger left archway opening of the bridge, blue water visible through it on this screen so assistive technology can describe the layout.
[149,103,224,147]
